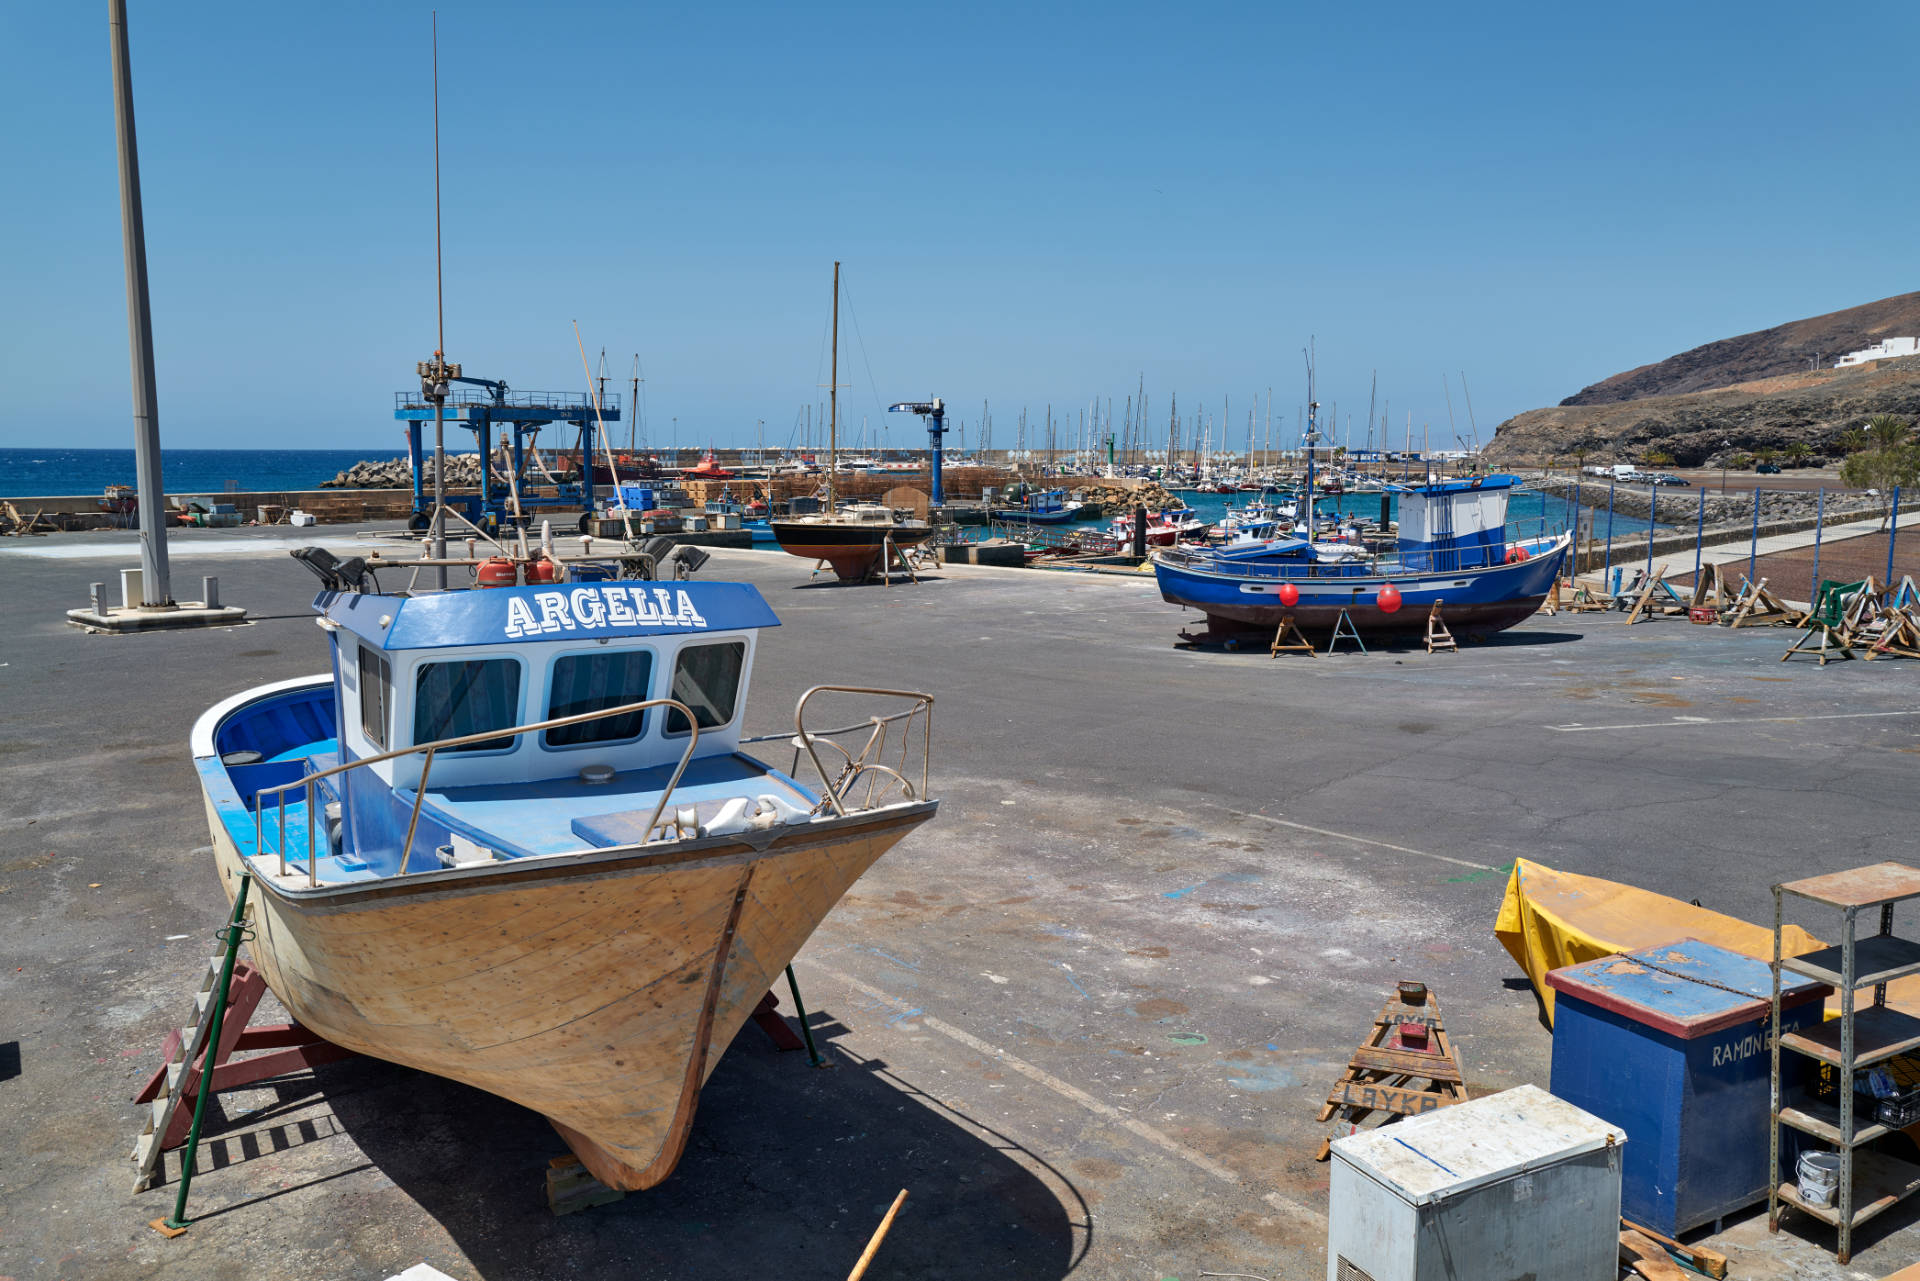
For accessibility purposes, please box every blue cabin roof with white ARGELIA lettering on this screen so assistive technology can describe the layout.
[313,582,780,649]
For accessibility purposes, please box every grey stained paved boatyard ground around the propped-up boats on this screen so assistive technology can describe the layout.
[0,530,1920,1281]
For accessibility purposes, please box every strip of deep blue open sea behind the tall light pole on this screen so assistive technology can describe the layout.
[0,447,424,497]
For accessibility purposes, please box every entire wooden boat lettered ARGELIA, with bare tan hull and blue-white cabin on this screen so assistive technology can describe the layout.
[192,572,937,1189]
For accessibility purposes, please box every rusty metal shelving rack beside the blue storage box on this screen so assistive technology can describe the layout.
[1766,862,1920,1264]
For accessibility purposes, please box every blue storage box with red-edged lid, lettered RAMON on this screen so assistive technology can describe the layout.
[1548,939,1832,1237]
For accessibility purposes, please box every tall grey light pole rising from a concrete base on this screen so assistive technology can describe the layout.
[108,0,173,609]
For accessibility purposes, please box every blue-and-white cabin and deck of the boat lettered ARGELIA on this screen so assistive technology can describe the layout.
[194,582,818,883]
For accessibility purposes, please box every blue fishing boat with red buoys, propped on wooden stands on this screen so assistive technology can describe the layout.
[1154,476,1572,643]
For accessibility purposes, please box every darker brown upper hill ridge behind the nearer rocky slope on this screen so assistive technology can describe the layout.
[1561,294,1920,405]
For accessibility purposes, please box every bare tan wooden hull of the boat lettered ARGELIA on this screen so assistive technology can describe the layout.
[207,801,937,1191]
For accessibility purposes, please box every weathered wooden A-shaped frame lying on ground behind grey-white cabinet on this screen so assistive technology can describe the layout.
[1313,981,1467,1160]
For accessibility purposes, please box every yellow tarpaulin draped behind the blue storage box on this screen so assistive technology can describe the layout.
[1494,858,1827,1022]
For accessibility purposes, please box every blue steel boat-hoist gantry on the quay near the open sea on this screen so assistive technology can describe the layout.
[394,363,620,530]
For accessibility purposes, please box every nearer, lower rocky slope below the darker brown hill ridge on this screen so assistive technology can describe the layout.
[1486,357,1920,467]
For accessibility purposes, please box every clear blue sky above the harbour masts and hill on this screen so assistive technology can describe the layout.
[0,0,1920,447]
